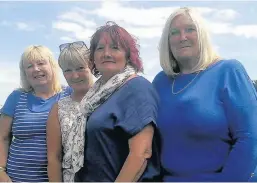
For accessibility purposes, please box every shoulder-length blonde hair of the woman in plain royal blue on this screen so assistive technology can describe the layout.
[159,7,219,77]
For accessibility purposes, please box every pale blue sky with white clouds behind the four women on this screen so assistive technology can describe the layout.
[0,1,257,104]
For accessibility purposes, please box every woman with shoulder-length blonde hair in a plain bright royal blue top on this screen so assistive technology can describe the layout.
[153,8,257,182]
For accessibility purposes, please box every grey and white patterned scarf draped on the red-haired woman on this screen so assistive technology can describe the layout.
[67,65,136,177]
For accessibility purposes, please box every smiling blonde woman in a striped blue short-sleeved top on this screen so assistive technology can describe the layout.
[0,46,71,182]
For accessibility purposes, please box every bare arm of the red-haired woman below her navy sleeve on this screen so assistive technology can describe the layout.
[115,125,154,182]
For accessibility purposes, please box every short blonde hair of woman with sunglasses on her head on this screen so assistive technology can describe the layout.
[58,42,89,70]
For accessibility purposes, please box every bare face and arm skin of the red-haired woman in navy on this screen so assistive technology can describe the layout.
[94,33,154,182]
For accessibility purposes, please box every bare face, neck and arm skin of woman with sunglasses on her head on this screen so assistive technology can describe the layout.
[46,64,93,182]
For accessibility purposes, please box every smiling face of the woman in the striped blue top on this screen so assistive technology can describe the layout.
[23,60,53,89]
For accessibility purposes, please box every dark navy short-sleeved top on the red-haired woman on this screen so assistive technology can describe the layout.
[75,77,160,182]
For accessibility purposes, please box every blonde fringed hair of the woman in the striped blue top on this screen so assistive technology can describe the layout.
[20,45,62,93]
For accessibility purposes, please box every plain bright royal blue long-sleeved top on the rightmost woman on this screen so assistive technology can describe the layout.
[153,60,257,182]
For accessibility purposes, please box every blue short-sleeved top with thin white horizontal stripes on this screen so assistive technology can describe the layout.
[2,87,71,182]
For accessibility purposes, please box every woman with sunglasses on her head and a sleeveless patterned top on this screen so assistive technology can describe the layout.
[47,41,93,182]
